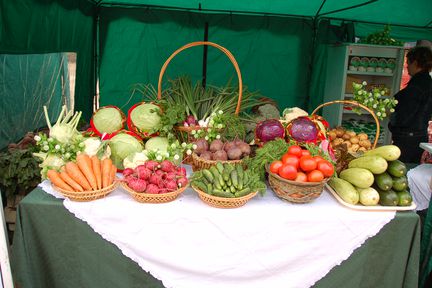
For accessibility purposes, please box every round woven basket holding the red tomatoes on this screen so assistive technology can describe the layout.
[268,172,330,203]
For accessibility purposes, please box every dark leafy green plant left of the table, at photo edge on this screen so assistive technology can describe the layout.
[0,147,41,196]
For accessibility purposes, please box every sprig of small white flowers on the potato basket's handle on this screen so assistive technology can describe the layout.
[353,81,398,120]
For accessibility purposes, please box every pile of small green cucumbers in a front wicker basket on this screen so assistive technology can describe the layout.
[191,162,266,198]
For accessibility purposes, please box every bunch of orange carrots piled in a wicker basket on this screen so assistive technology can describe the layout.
[47,154,117,192]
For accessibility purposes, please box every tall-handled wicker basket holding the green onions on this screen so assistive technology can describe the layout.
[157,41,243,142]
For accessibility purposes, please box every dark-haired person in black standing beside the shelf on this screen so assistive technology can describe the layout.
[389,46,432,164]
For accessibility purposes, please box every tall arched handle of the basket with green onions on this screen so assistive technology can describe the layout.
[157,41,243,115]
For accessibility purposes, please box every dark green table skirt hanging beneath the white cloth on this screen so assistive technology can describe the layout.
[11,188,420,288]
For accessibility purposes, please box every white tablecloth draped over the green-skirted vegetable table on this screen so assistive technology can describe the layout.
[41,166,395,288]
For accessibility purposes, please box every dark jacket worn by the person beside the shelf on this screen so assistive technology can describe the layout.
[389,72,432,135]
